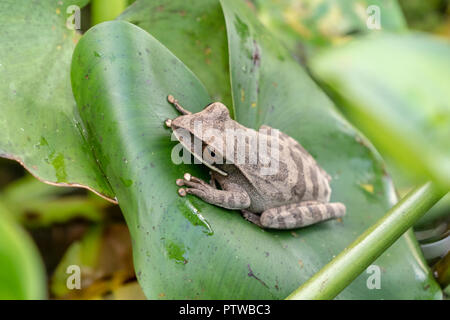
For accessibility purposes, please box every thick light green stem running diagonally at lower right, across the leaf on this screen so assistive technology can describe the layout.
[287,182,445,300]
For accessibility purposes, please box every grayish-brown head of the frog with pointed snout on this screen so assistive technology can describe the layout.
[166,99,233,176]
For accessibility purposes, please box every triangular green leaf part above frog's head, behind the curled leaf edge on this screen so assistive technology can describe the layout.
[119,0,231,109]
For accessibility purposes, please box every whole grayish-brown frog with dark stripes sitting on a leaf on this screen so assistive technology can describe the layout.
[166,95,346,229]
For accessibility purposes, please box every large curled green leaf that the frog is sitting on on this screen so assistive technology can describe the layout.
[72,5,440,299]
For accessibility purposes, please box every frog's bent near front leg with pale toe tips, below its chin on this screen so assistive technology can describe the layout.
[176,173,251,209]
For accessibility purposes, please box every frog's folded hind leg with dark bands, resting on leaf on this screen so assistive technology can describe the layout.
[260,201,345,229]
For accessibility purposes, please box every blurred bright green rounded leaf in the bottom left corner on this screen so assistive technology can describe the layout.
[0,207,47,300]
